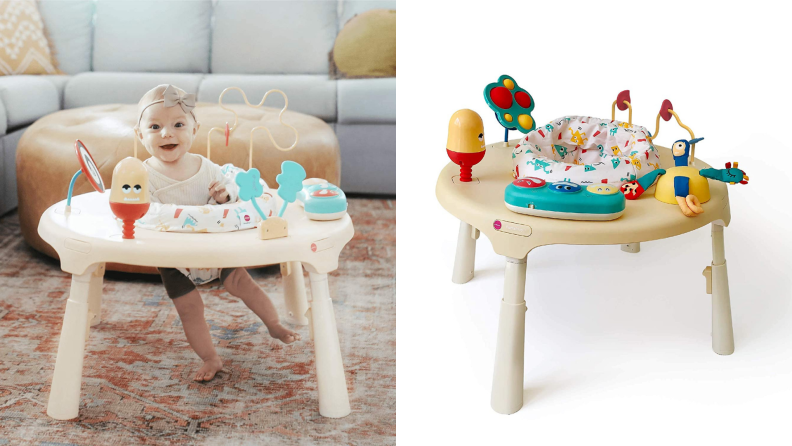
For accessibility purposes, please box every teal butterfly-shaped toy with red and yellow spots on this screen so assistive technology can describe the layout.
[484,74,536,133]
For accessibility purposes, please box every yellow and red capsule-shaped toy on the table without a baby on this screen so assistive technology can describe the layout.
[446,109,486,183]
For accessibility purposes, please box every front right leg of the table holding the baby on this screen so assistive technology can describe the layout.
[309,273,351,418]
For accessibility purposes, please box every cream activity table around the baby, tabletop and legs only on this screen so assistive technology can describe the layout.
[38,192,354,420]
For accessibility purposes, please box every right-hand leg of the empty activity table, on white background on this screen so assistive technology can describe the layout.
[712,223,734,355]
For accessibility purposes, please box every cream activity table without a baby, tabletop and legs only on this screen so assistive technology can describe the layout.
[436,140,734,414]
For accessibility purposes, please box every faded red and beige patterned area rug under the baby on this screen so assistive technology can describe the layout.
[0,198,396,445]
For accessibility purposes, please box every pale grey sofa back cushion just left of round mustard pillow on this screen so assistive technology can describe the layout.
[212,0,338,74]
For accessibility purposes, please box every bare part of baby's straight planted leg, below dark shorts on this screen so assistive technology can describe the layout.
[173,290,223,381]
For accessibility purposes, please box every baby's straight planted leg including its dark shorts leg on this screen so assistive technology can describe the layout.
[158,268,223,381]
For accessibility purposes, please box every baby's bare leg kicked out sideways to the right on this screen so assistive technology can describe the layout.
[221,268,300,344]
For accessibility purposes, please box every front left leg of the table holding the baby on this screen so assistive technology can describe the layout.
[47,265,99,420]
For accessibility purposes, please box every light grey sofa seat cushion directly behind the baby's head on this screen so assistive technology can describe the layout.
[63,73,203,108]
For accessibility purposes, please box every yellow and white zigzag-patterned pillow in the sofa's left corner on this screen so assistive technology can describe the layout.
[0,0,61,76]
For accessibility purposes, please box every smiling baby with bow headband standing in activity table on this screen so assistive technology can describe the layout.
[135,85,300,381]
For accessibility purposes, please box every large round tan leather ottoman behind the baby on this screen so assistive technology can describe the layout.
[16,104,341,273]
